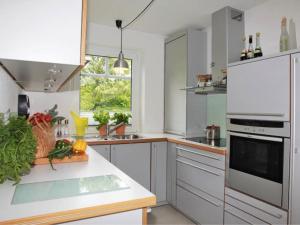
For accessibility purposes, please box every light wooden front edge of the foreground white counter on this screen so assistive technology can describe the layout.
[0,196,156,225]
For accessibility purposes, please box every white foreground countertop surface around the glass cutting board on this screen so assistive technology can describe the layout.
[0,147,154,223]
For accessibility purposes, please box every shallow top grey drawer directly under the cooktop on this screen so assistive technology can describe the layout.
[176,145,225,170]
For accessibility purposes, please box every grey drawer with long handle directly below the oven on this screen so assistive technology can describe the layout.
[225,188,287,224]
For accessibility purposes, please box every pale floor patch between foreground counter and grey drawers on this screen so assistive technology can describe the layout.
[148,205,195,225]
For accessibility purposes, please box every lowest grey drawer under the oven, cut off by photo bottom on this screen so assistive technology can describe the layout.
[224,204,267,225]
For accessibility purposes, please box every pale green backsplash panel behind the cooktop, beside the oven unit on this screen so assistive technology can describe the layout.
[207,94,226,138]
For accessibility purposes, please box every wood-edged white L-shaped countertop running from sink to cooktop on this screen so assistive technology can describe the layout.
[87,133,226,155]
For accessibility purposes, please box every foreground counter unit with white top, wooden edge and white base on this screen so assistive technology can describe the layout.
[0,147,156,225]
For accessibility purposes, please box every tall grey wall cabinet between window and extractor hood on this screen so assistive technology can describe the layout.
[164,30,207,136]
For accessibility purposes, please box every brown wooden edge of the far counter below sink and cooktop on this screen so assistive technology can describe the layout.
[88,138,226,155]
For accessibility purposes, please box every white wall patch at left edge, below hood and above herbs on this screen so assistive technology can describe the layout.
[0,67,20,113]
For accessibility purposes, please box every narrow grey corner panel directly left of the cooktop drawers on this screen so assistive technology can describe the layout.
[167,142,177,206]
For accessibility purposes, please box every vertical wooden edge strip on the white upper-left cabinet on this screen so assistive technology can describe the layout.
[80,0,87,66]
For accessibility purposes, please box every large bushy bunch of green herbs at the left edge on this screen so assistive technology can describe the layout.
[0,116,36,184]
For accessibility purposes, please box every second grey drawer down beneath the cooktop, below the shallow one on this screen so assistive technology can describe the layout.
[176,157,225,199]
